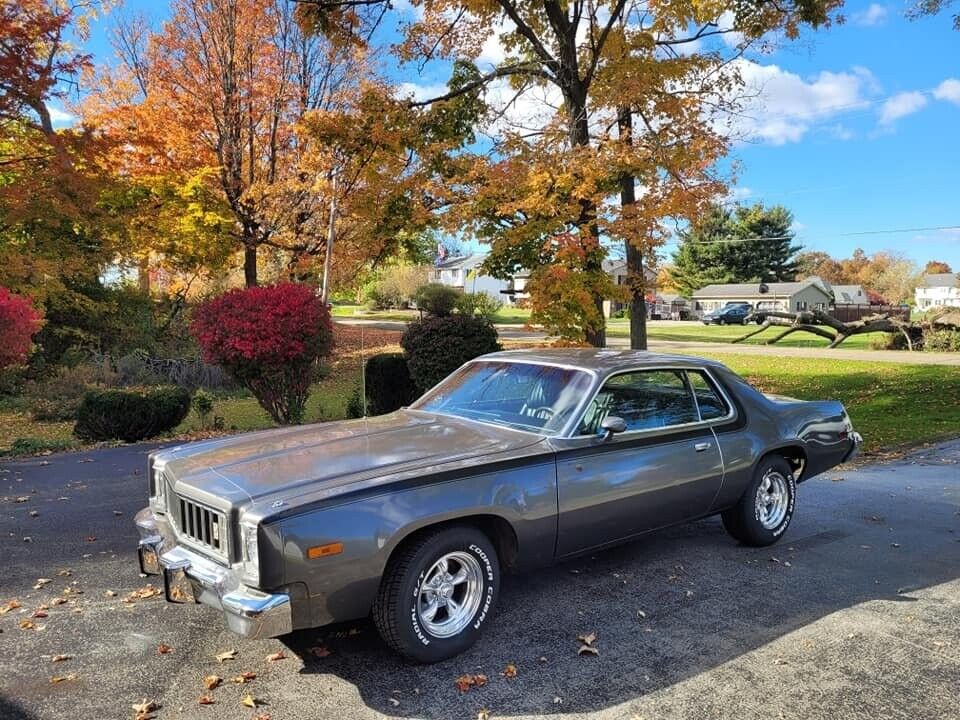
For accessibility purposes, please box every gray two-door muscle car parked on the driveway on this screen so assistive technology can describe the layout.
[136,349,860,662]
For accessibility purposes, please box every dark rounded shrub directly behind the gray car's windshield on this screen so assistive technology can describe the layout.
[400,315,500,393]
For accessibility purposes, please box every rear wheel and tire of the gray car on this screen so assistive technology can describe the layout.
[721,455,797,547]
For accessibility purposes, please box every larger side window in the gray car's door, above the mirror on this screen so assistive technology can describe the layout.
[579,370,698,435]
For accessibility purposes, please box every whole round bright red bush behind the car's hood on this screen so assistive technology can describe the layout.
[190,283,333,425]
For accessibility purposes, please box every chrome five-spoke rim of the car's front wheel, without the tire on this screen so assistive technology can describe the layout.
[417,551,483,638]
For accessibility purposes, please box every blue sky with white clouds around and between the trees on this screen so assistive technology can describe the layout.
[69,0,960,271]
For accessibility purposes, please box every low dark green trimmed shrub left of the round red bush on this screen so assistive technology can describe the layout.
[73,388,190,442]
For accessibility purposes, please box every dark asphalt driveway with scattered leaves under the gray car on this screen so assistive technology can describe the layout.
[0,441,960,720]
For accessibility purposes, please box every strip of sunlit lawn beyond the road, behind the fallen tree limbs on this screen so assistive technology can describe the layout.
[607,319,886,350]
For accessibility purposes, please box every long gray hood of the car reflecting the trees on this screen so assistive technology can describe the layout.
[157,410,543,506]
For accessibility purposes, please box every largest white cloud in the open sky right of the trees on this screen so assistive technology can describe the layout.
[731,60,875,145]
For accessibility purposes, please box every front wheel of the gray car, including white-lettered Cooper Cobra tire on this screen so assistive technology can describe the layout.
[373,526,500,663]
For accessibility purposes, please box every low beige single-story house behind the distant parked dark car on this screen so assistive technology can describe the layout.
[693,277,833,315]
